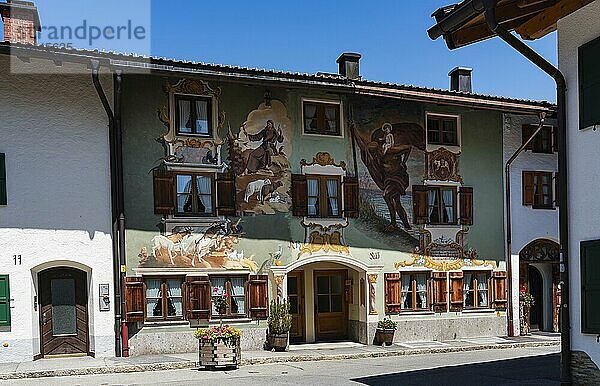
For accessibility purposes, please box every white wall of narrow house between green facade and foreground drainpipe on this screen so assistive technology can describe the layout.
[503,114,558,334]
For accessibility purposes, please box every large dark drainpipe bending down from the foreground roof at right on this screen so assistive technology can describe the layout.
[484,0,571,385]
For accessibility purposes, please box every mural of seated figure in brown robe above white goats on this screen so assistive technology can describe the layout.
[228,100,292,215]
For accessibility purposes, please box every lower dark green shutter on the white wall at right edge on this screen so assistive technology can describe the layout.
[580,240,600,334]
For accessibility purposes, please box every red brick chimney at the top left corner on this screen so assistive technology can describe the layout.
[0,0,41,44]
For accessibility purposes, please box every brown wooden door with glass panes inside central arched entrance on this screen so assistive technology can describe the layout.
[314,271,348,341]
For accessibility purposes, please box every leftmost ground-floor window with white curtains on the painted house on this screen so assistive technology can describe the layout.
[146,278,183,320]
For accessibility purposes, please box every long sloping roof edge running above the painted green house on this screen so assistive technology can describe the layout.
[0,42,554,113]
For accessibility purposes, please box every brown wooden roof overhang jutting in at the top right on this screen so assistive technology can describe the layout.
[427,0,594,49]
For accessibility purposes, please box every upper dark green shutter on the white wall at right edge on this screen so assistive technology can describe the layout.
[579,37,600,130]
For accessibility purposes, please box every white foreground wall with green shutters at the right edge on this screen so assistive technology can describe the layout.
[558,1,600,366]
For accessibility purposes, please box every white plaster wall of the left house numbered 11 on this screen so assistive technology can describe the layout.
[0,55,114,362]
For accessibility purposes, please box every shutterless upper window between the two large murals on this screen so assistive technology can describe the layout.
[302,102,341,136]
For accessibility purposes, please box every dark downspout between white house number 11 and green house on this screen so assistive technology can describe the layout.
[91,59,121,357]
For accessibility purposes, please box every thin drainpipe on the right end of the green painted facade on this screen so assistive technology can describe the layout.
[504,112,546,336]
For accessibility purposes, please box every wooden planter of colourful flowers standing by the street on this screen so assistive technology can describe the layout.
[194,288,242,369]
